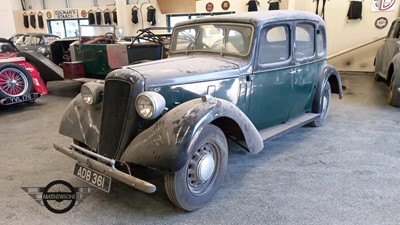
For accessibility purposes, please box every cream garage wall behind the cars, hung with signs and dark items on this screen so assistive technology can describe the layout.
[8,0,400,71]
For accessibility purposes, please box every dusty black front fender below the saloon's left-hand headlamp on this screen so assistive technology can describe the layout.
[59,94,103,149]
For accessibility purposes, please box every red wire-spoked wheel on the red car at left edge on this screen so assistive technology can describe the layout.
[0,64,32,98]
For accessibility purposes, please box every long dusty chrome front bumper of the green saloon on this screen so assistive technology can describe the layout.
[53,143,157,193]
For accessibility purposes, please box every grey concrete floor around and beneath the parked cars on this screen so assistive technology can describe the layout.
[0,74,400,225]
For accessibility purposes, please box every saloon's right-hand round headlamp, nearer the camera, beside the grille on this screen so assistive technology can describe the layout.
[136,91,165,120]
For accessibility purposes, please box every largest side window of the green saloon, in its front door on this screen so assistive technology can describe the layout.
[258,25,290,64]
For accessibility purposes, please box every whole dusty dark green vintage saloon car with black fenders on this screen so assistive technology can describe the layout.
[54,11,342,211]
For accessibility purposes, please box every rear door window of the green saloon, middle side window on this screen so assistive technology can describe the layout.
[295,23,315,60]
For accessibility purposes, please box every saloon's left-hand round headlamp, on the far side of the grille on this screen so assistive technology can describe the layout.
[81,81,104,105]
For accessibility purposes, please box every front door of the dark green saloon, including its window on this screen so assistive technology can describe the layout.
[248,22,296,129]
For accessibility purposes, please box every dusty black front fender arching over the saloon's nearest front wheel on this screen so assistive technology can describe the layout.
[121,97,264,171]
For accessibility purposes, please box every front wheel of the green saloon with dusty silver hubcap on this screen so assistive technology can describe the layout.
[164,124,228,211]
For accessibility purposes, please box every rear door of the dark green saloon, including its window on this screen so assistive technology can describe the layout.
[289,21,325,118]
